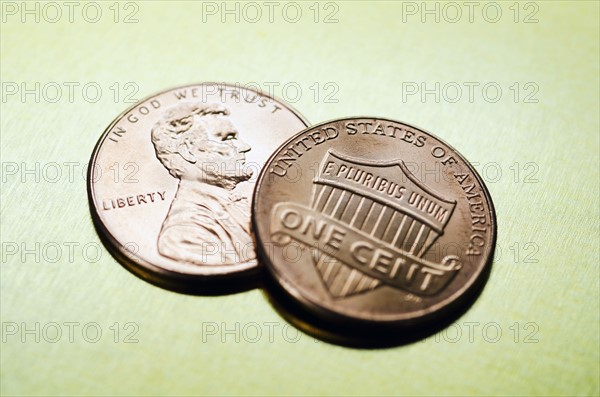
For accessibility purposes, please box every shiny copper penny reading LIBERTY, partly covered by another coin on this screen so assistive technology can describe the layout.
[88,83,307,285]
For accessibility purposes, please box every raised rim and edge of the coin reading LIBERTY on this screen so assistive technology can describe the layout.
[86,82,310,292]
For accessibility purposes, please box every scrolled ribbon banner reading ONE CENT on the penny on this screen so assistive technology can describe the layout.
[271,202,461,295]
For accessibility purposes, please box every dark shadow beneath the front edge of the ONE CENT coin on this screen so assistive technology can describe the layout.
[261,260,491,349]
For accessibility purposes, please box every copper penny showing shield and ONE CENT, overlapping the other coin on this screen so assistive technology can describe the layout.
[252,117,496,326]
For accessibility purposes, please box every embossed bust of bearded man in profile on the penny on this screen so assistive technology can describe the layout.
[151,103,255,265]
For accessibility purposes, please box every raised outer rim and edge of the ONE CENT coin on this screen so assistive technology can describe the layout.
[252,116,497,326]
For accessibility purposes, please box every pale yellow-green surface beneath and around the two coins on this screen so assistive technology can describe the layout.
[0,1,600,395]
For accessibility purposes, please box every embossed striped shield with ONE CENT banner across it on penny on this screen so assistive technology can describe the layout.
[272,150,460,298]
